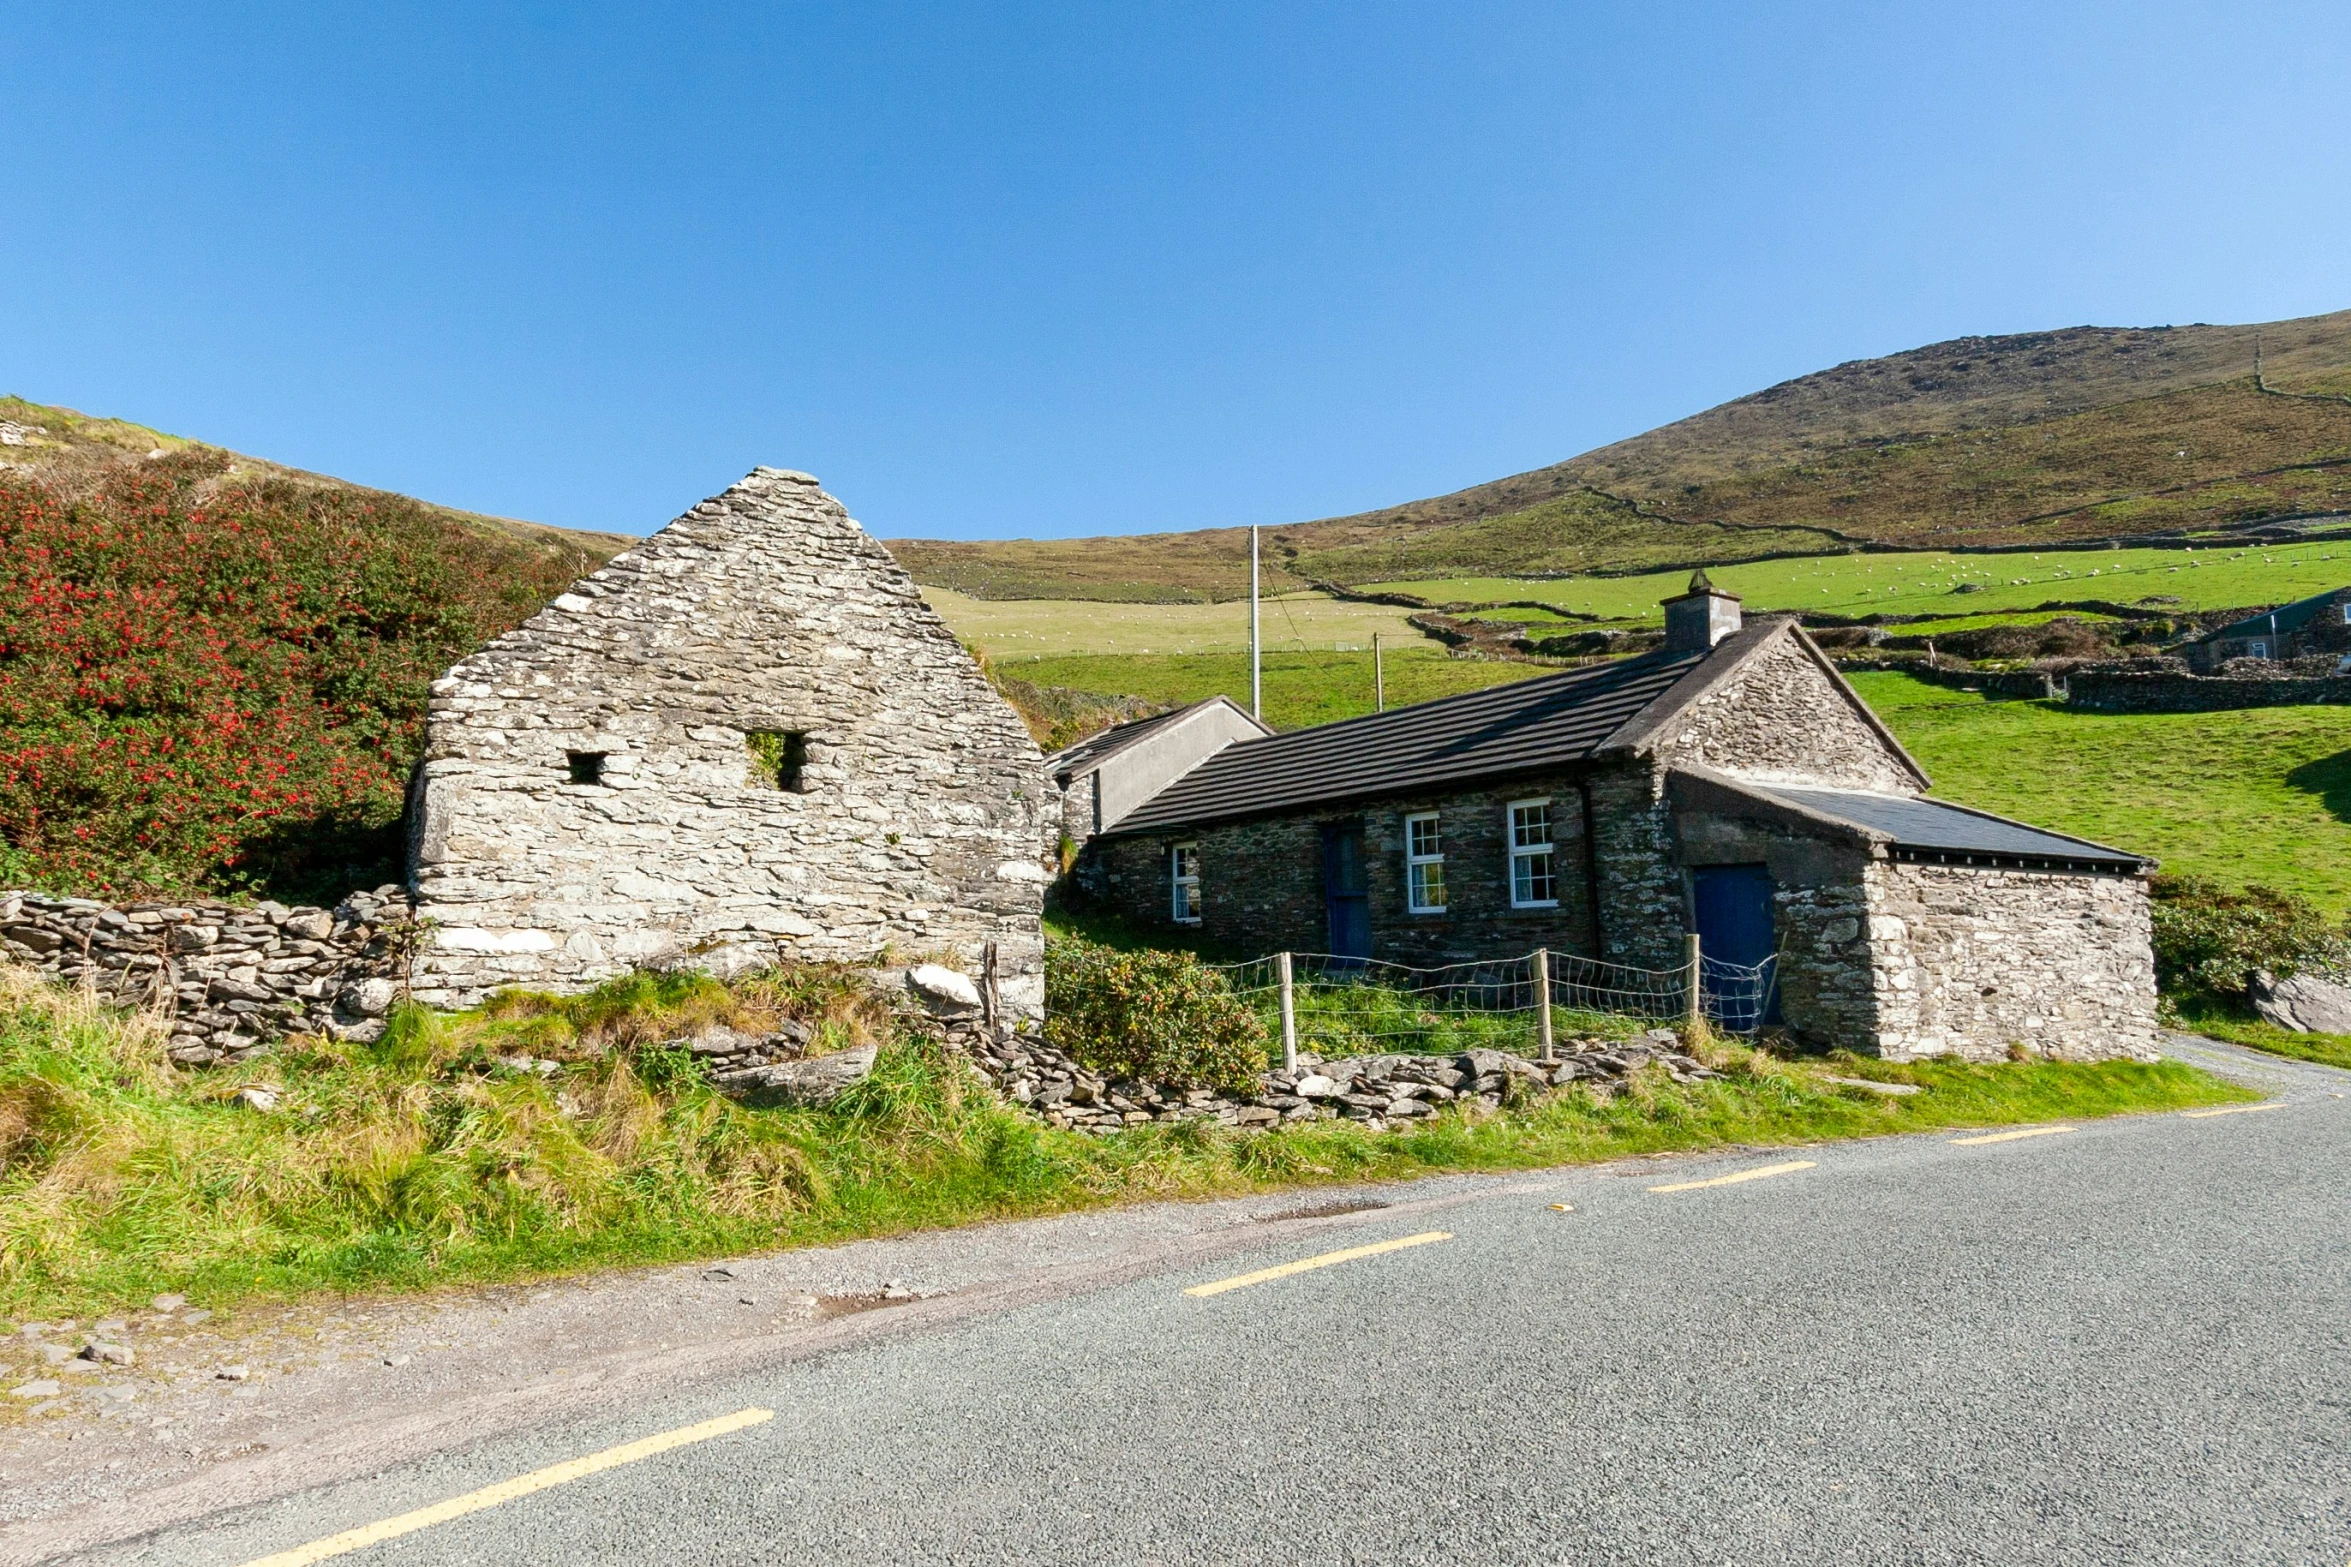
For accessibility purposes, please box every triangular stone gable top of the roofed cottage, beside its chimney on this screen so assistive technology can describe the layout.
[1657,630,1925,794]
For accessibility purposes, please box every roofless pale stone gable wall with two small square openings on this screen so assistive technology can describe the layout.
[411,468,1058,1008]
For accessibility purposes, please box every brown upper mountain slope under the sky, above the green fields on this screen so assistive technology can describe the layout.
[891,310,2351,599]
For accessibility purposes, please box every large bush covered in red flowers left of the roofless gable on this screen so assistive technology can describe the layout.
[0,449,585,897]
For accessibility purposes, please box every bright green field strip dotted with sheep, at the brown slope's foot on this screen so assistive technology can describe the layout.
[1368,540,2351,620]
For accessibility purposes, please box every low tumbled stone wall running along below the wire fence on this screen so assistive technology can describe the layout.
[943,1017,1721,1132]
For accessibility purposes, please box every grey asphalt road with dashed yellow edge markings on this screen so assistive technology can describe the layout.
[89,1043,2351,1567]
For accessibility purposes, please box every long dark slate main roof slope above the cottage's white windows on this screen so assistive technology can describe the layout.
[1112,648,1711,836]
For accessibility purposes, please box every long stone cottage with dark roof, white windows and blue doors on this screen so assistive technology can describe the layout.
[1079,573,2156,1060]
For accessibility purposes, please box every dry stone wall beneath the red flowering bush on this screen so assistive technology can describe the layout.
[0,886,414,1067]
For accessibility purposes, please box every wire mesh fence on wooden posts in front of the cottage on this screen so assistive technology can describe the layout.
[1218,940,1777,1060]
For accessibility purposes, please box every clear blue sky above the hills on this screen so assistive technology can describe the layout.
[0,0,2351,538]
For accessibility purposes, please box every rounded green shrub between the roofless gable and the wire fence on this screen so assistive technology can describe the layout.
[1044,942,1267,1090]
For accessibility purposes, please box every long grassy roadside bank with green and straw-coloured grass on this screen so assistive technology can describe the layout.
[0,975,2245,1318]
